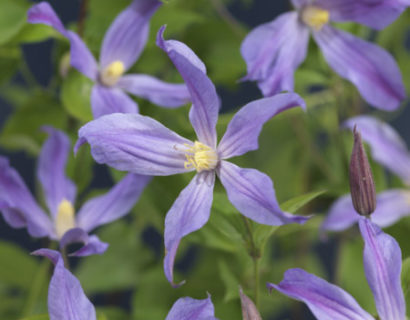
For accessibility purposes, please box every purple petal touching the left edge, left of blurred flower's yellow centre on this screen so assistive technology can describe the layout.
[0,157,53,237]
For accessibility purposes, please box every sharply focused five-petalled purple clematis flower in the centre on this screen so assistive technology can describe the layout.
[76,27,308,282]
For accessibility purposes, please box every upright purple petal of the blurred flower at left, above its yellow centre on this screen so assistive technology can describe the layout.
[37,127,76,217]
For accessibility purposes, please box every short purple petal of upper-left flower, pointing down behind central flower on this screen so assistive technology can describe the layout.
[91,84,138,119]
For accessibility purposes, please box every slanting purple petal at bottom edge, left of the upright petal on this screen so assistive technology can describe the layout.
[267,269,374,320]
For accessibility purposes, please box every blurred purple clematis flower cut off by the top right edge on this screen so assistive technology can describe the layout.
[241,0,410,111]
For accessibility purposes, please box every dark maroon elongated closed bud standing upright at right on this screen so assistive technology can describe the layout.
[350,126,376,216]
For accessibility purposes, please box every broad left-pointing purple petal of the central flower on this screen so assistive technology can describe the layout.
[75,113,192,176]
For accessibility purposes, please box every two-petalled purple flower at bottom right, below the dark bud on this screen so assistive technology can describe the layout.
[267,217,406,320]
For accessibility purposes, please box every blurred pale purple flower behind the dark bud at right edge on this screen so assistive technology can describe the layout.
[321,116,410,231]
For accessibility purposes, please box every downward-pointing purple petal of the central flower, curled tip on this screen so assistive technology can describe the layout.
[164,171,215,287]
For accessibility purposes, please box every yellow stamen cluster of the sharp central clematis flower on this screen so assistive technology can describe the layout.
[184,141,219,172]
